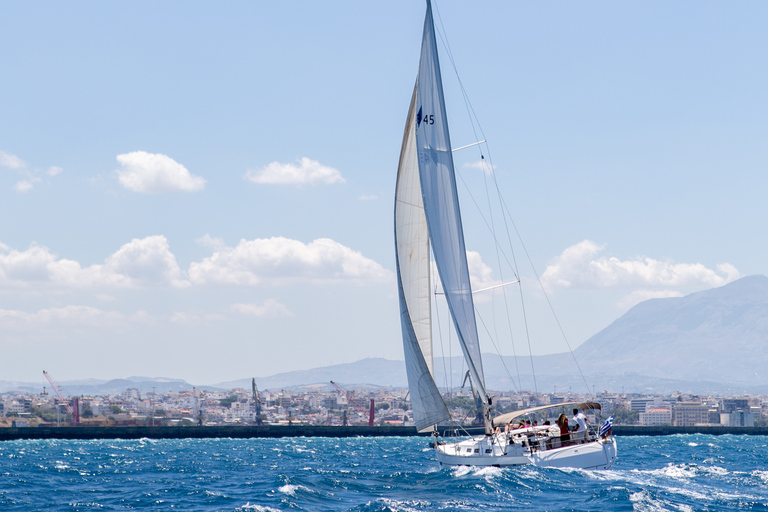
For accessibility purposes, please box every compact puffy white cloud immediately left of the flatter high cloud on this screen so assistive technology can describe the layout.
[115,151,205,194]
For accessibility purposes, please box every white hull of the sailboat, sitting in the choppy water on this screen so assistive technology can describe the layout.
[435,434,616,469]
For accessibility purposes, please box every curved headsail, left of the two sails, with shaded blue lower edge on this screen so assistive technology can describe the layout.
[395,84,449,431]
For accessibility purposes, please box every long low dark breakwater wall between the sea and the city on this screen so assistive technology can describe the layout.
[0,425,768,441]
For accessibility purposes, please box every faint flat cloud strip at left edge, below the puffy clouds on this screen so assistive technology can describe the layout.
[0,306,131,331]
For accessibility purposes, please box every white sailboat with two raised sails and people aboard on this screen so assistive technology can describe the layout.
[395,0,616,469]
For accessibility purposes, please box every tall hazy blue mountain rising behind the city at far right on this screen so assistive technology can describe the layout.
[575,276,768,386]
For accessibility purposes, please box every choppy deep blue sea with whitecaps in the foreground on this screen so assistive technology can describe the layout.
[0,435,768,512]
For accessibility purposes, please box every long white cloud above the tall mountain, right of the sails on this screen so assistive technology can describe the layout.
[541,240,739,289]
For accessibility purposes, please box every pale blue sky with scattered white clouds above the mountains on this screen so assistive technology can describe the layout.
[0,0,768,384]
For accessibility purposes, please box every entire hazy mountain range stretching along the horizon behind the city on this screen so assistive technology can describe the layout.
[6,275,768,395]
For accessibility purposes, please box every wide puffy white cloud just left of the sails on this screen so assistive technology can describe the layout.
[189,237,392,286]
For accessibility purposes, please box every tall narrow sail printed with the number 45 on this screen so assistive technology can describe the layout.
[415,1,488,392]
